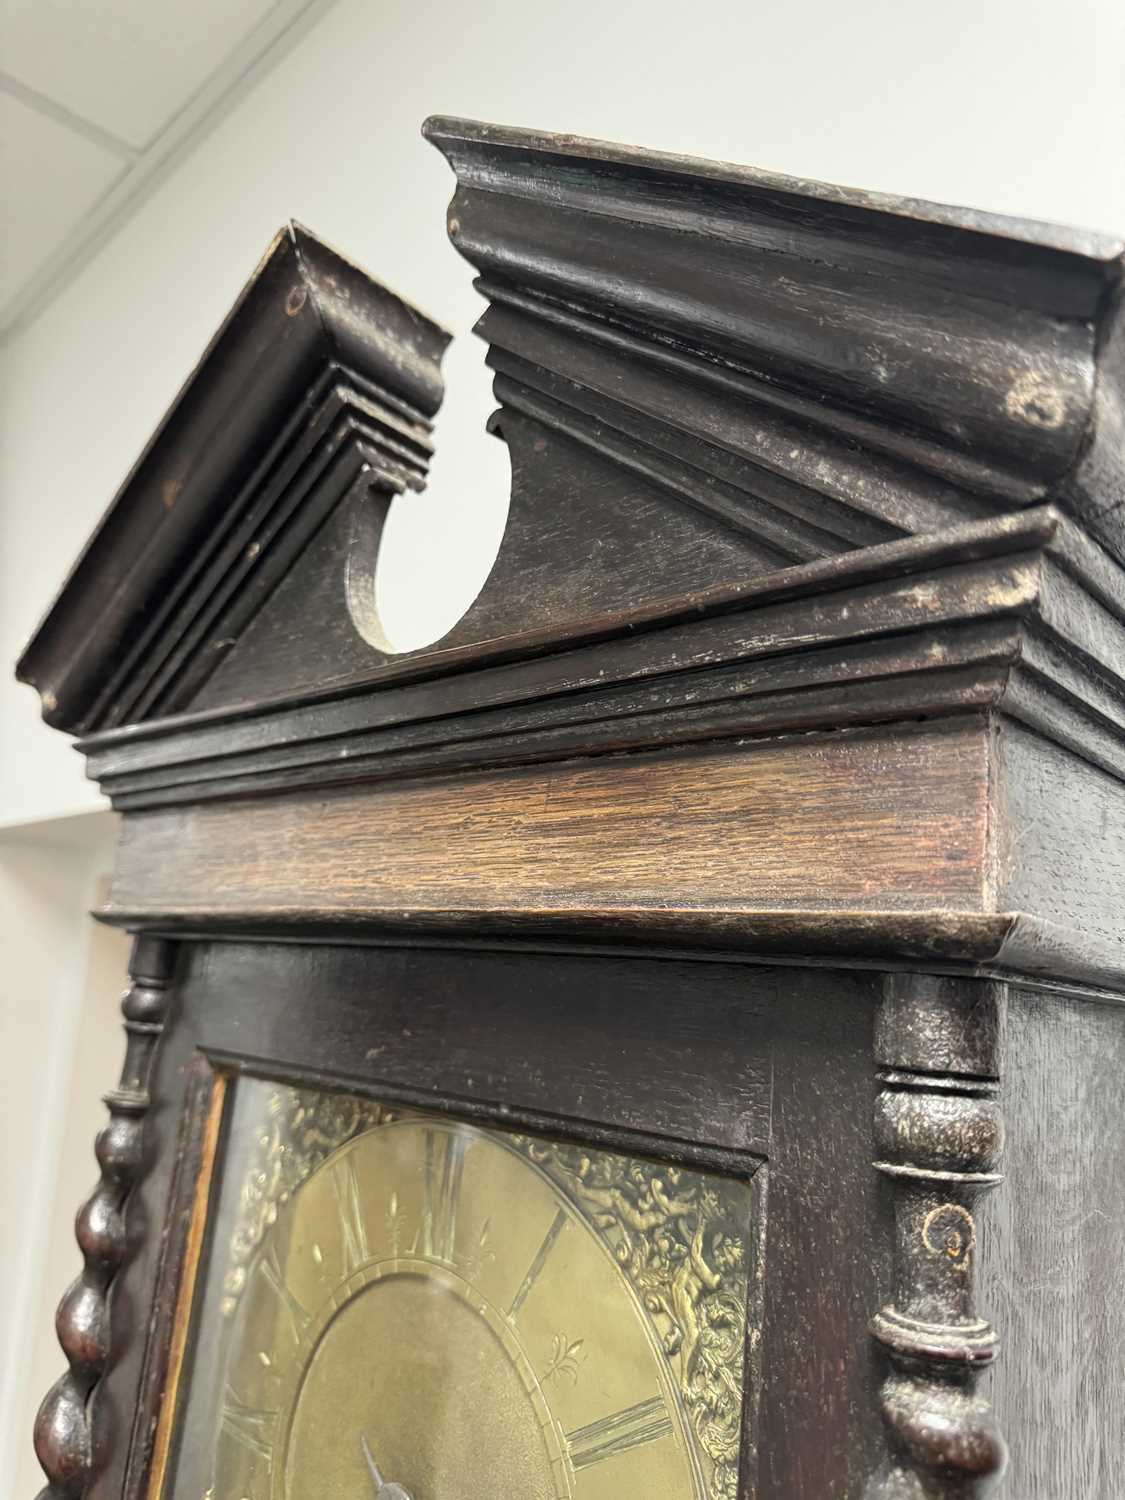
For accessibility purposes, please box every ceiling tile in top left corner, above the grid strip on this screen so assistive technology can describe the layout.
[0,0,276,149]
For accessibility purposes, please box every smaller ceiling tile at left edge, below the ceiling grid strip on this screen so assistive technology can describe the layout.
[0,93,125,308]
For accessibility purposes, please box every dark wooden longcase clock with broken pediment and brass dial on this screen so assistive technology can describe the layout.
[20,120,1125,1500]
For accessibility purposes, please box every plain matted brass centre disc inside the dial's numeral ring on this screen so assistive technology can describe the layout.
[285,1268,570,1500]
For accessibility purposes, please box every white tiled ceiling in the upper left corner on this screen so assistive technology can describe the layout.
[0,0,332,336]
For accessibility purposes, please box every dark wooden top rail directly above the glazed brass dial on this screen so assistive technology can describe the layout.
[185,944,780,1157]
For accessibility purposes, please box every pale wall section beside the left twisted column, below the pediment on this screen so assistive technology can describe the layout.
[0,813,129,1497]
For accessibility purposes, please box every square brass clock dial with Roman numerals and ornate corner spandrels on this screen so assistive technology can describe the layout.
[173,1083,752,1500]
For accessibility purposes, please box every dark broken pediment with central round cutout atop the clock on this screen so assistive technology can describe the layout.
[21,130,1125,731]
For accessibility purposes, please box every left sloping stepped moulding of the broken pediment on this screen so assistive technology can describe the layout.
[17,224,449,734]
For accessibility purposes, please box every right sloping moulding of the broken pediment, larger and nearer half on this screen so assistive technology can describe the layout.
[425,119,1125,557]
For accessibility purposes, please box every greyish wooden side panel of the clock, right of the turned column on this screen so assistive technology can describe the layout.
[981,987,1125,1500]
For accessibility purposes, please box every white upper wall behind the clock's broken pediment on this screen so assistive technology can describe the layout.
[0,0,1125,822]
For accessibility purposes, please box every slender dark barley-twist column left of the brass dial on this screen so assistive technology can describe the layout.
[35,936,174,1500]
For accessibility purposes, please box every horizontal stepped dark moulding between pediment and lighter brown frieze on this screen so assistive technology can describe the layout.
[80,507,1125,810]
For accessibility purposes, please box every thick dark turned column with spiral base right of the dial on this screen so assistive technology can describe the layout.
[867,974,1007,1500]
